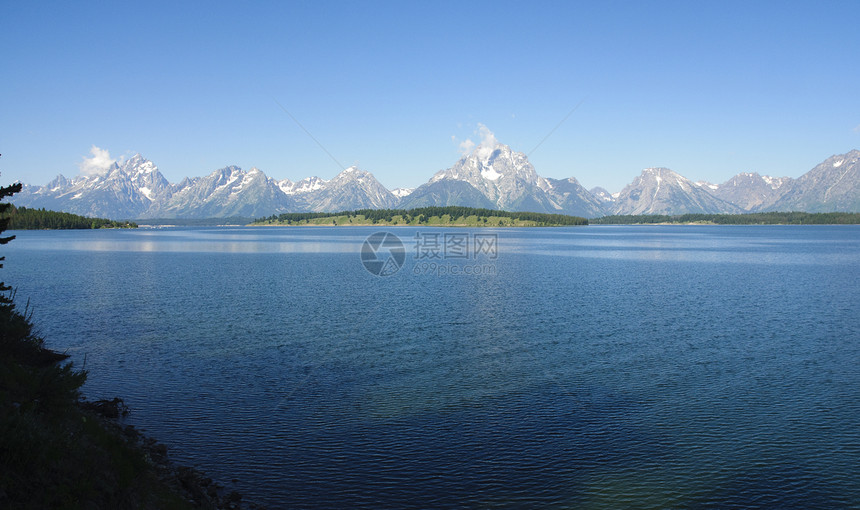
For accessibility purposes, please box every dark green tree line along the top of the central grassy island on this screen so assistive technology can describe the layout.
[255,206,588,225]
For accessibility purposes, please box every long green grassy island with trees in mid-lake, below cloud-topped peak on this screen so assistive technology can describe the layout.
[251,206,588,227]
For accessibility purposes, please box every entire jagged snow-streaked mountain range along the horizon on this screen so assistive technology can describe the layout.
[15,140,860,219]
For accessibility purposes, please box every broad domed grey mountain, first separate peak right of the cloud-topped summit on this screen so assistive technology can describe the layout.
[612,168,743,214]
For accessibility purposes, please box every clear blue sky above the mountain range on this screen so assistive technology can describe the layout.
[0,0,860,192]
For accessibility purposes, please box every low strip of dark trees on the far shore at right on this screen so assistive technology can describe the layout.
[590,212,860,225]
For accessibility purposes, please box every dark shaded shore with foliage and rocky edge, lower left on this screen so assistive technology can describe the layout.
[0,177,256,510]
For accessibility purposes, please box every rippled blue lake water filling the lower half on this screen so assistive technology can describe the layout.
[0,226,860,508]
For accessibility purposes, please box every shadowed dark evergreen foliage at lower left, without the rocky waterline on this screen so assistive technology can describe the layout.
[0,179,168,508]
